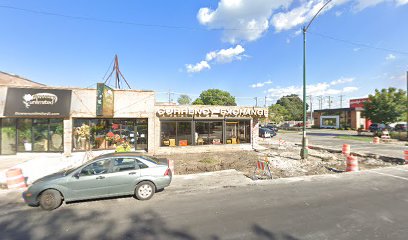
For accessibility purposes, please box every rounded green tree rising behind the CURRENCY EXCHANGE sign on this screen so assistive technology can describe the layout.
[193,89,237,106]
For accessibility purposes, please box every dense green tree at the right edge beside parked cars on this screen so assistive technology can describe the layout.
[364,87,408,124]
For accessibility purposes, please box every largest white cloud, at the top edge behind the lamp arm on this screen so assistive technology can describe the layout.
[197,0,408,44]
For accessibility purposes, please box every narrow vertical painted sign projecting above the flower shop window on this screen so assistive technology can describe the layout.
[96,83,114,117]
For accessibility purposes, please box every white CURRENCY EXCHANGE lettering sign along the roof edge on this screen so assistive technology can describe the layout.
[156,108,268,117]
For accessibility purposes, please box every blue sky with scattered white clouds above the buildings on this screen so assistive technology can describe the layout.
[0,0,408,107]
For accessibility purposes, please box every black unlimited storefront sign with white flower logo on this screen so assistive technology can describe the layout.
[4,88,72,117]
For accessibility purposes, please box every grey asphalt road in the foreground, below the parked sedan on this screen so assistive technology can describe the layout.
[0,166,408,240]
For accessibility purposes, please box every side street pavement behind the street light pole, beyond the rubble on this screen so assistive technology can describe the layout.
[274,129,408,158]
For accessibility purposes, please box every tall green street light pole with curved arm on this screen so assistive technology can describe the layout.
[300,0,332,159]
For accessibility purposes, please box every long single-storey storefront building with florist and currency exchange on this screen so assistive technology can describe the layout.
[0,84,268,156]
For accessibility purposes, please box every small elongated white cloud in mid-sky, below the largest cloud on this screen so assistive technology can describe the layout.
[186,45,245,73]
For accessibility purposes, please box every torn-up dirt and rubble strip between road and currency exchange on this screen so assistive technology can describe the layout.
[158,144,398,178]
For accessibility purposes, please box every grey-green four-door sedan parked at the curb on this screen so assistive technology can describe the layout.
[23,153,172,211]
